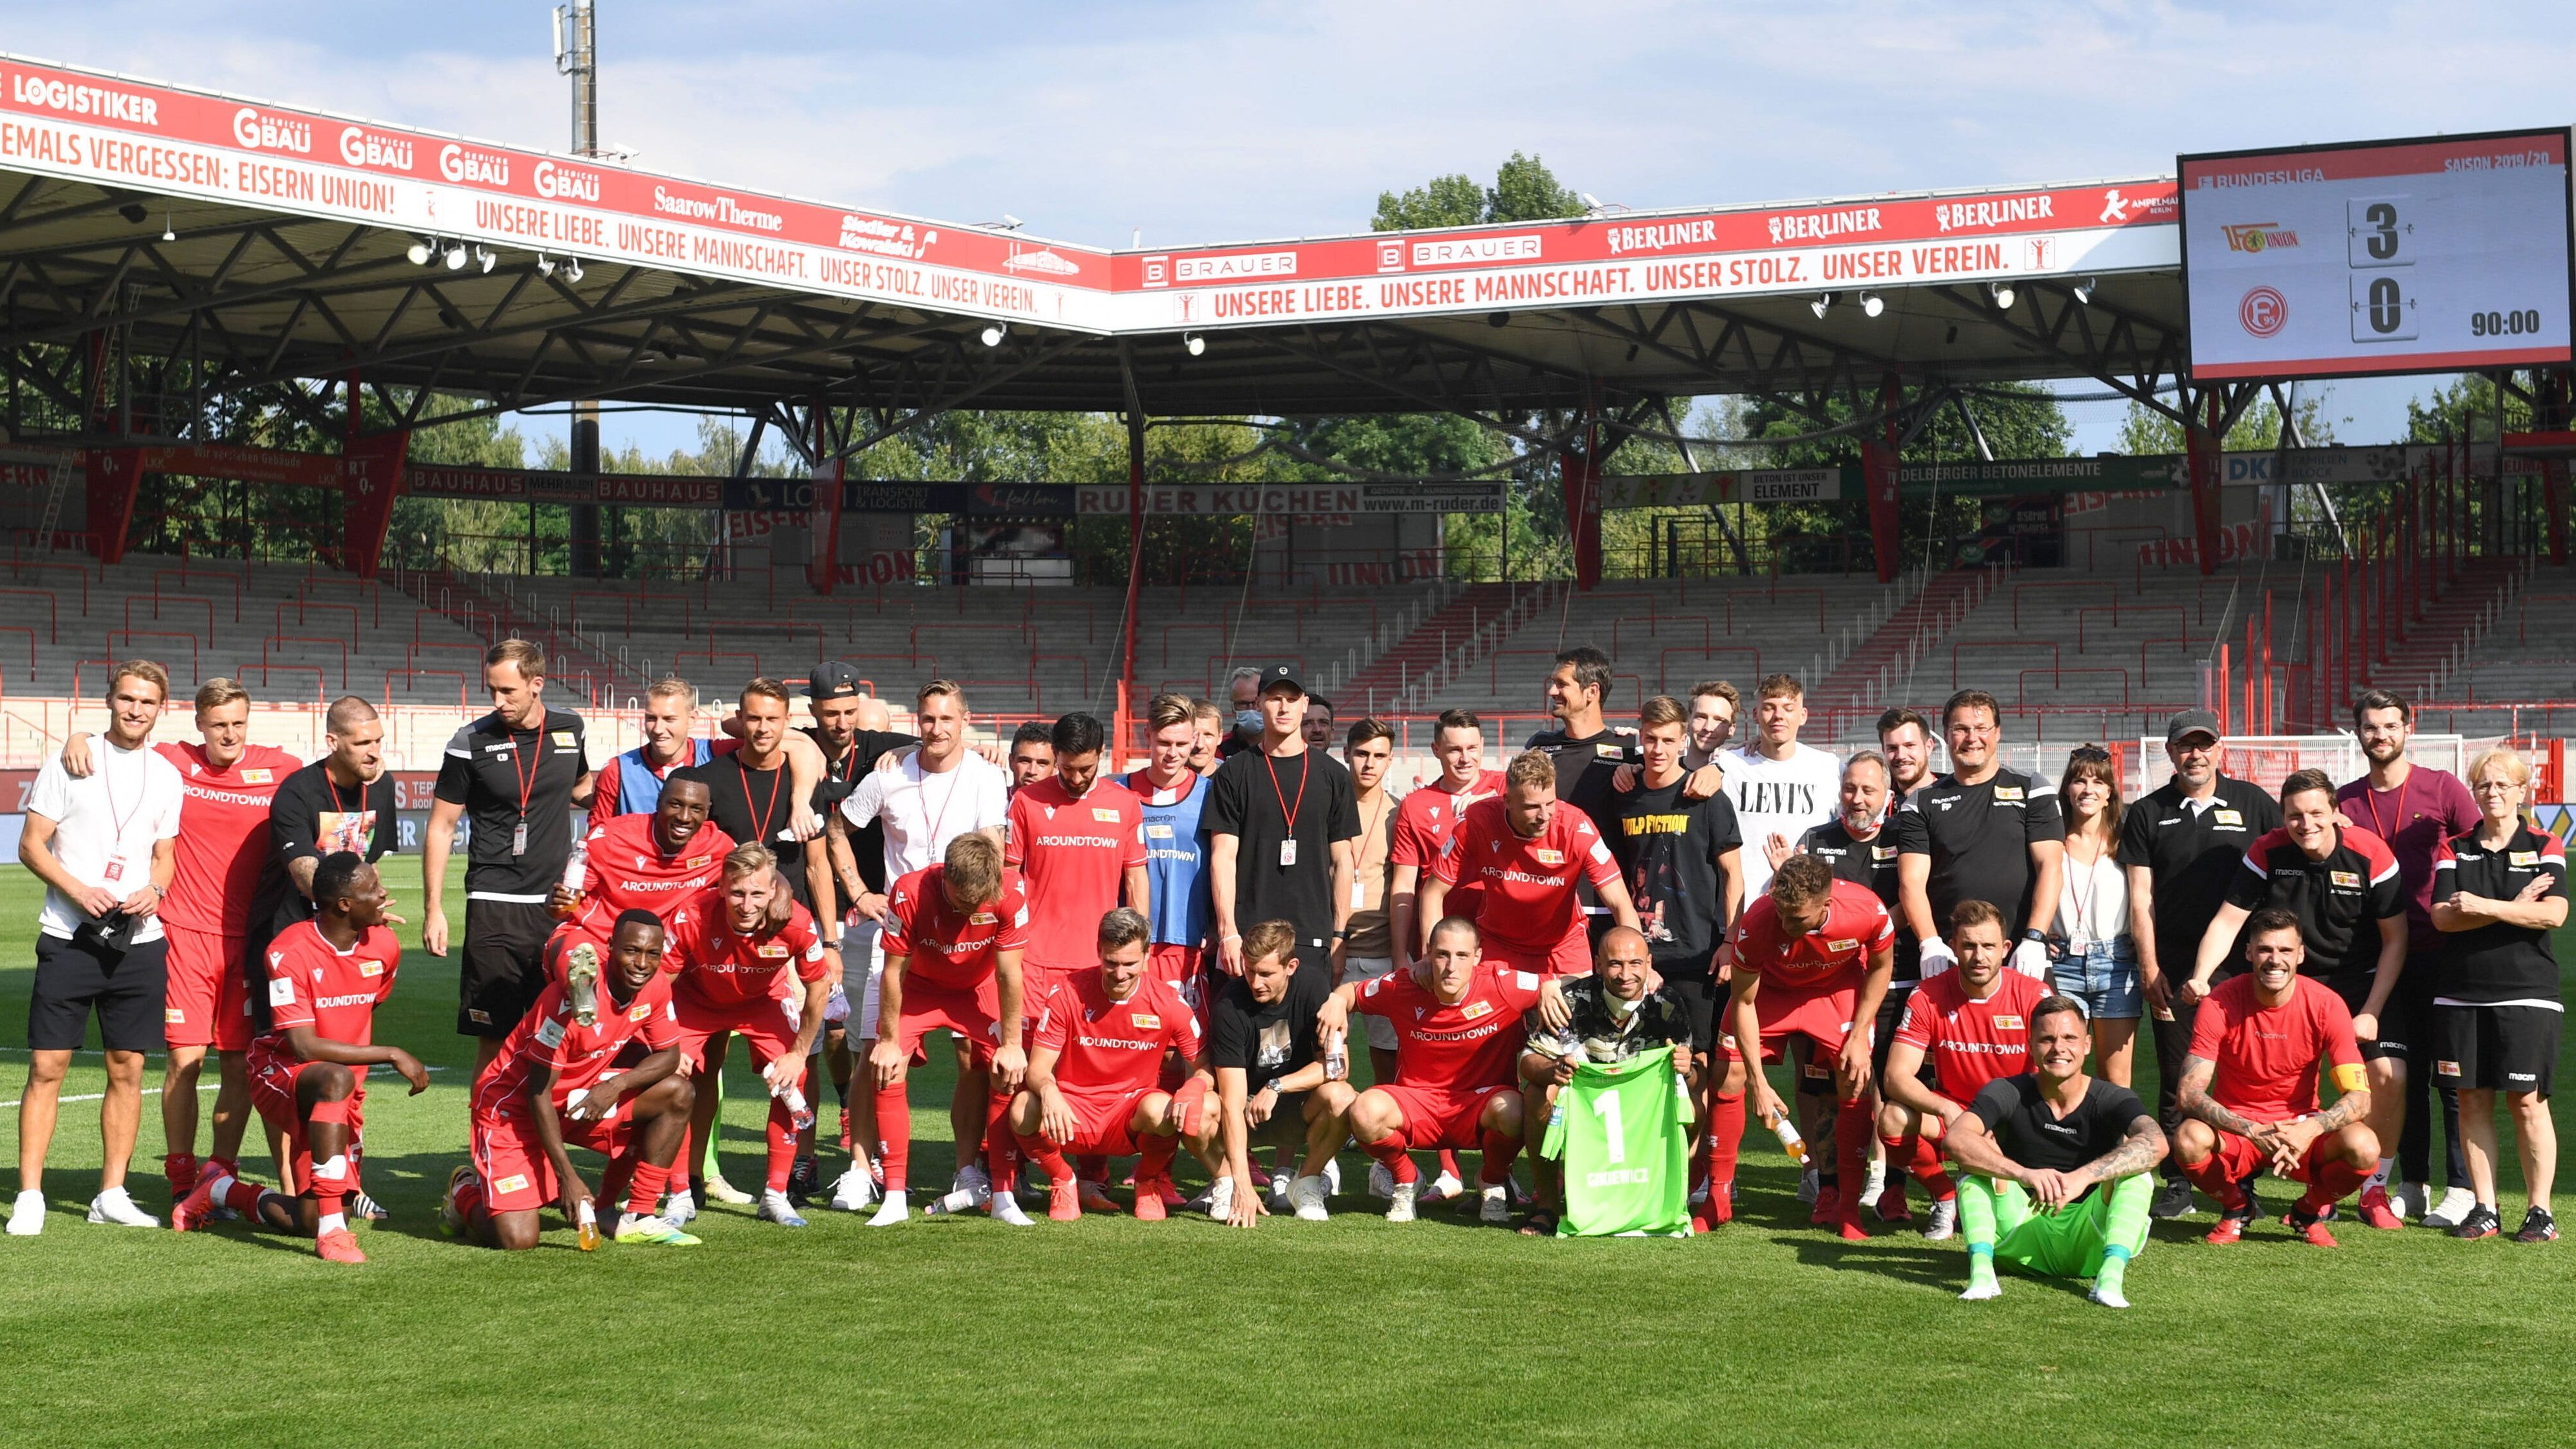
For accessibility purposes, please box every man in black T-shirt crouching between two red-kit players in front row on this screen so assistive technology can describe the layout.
[1208,921,1350,1228]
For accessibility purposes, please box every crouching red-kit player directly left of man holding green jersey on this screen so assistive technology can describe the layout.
[1319,916,1566,1225]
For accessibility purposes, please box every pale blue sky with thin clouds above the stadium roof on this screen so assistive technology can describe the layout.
[0,0,2576,448]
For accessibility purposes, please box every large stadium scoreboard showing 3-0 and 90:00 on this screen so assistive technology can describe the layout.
[2177,126,2576,381]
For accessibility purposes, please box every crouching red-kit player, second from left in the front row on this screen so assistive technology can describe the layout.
[443,908,698,1254]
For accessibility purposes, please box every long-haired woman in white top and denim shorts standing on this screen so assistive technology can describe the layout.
[2048,744,2141,1086]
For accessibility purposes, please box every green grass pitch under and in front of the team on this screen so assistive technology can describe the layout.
[0,860,2576,1449]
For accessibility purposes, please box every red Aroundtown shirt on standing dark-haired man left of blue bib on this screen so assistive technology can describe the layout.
[1002,778,1144,970]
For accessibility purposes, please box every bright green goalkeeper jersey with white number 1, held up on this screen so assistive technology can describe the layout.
[1546,1047,1690,1238]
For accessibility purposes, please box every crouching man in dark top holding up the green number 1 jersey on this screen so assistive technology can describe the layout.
[1520,926,1693,1238]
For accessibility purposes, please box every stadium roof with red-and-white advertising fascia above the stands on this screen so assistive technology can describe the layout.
[0,57,2185,450]
